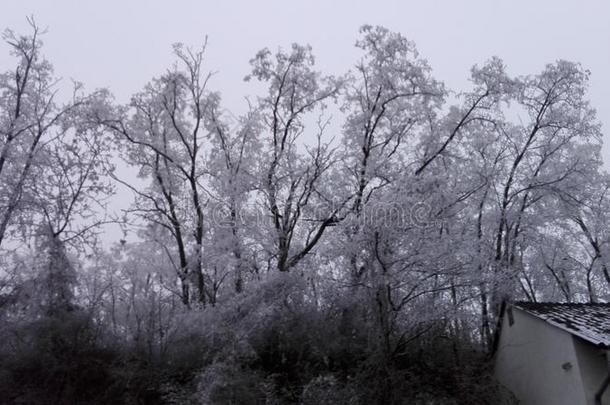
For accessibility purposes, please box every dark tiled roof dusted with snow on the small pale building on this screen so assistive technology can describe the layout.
[513,302,610,348]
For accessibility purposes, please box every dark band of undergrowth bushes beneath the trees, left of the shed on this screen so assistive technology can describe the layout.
[0,274,499,405]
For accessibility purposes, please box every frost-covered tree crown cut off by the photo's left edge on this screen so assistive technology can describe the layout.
[0,19,111,246]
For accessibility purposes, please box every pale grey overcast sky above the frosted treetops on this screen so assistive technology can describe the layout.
[0,0,610,167]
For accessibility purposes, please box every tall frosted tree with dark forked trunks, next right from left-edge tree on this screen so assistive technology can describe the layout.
[96,44,219,305]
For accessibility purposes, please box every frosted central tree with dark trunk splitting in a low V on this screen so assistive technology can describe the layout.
[248,44,345,272]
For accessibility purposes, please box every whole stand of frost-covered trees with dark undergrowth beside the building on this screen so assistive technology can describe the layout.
[0,20,610,405]
